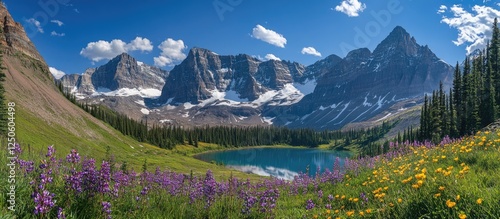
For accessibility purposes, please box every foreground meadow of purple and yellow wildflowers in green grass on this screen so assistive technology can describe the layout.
[0,129,500,218]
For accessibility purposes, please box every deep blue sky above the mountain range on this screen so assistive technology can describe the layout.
[3,0,500,77]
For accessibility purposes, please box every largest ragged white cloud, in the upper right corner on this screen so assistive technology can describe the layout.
[441,5,500,54]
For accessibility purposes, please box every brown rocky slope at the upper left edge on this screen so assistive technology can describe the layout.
[0,3,43,61]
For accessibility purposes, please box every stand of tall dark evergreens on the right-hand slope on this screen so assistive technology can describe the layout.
[419,19,500,142]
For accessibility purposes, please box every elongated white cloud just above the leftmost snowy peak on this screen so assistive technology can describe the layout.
[80,37,153,62]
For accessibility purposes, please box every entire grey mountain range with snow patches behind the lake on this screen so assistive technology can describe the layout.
[59,26,453,130]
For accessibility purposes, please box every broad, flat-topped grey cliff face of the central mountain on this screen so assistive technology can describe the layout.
[158,48,304,104]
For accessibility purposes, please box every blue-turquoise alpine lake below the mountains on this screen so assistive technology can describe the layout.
[195,147,350,180]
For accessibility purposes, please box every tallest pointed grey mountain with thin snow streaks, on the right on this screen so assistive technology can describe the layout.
[280,27,453,129]
